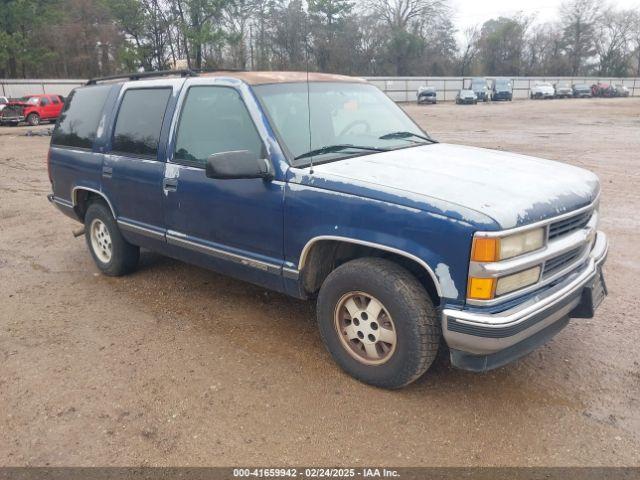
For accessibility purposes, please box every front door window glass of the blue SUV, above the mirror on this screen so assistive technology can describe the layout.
[174,86,262,167]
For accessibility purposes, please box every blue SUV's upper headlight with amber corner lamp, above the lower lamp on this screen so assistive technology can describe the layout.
[471,227,546,262]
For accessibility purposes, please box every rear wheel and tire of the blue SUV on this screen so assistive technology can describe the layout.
[84,201,140,277]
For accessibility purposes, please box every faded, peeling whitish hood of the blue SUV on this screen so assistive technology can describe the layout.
[300,143,600,229]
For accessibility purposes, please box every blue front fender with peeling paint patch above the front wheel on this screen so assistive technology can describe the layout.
[284,183,474,303]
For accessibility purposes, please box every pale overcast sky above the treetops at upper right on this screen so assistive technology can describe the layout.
[452,0,640,42]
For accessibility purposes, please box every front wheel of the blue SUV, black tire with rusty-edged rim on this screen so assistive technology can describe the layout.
[317,258,441,389]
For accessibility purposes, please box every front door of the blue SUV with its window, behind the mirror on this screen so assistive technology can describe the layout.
[163,84,284,289]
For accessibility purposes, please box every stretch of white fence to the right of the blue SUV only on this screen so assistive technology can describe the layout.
[365,77,640,102]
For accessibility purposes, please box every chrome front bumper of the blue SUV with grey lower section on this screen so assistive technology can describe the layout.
[442,232,608,371]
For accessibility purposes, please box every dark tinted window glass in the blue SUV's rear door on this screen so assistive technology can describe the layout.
[112,88,171,156]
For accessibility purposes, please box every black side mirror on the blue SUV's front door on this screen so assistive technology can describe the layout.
[206,150,273,180]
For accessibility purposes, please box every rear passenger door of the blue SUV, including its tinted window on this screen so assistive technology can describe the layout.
[102,85,173,247]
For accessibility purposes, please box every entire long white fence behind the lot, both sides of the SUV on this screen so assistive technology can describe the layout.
[0,77,640,102]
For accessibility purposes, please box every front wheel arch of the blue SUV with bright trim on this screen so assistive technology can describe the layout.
[298,235,443,305]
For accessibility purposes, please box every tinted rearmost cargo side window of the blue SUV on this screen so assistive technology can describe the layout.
[51,85,111,148]
